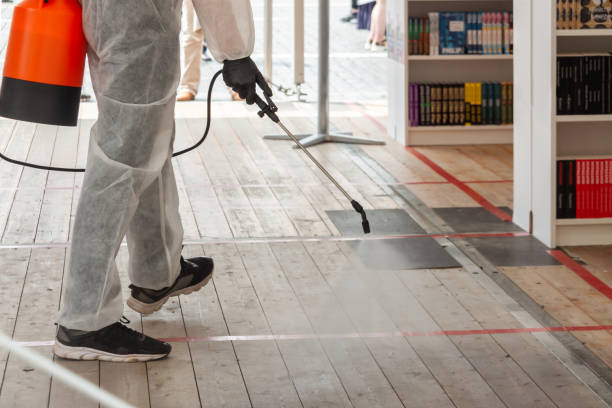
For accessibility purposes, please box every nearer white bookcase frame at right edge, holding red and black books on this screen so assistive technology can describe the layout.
[514,0,612,248]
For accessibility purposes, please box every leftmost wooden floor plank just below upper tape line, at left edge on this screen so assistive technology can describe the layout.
[0,249,31,391]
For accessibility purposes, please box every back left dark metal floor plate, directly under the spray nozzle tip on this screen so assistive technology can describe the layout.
[327,209,425,235]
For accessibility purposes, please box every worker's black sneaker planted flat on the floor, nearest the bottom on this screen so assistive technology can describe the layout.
[53,322,172,363]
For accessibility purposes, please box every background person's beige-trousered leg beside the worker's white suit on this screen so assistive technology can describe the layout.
[176,0,204,101]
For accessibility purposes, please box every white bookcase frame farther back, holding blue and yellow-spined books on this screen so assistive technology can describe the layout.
[387,0,513,146]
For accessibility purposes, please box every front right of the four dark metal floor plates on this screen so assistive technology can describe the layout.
[464,237,559,266]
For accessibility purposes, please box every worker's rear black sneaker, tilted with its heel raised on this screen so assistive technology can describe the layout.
[127,257,214,314]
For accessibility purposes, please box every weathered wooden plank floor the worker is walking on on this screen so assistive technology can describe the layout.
[0,103,612,408]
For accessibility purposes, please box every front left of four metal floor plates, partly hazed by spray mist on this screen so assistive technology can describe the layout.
[347,237,461,270]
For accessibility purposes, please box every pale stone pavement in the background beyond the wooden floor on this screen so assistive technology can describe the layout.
[0,0,387,102]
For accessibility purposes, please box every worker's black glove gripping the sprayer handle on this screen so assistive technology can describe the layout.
[223,57,272,105]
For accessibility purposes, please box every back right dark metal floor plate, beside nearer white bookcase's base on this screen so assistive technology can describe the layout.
[434,207,522,233]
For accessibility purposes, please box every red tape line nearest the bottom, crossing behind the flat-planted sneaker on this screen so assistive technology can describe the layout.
[16,325,612,347]
